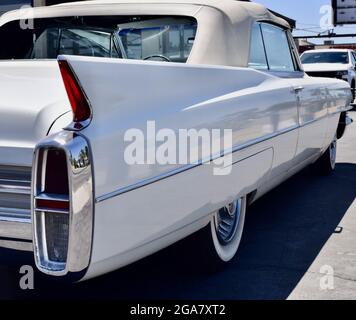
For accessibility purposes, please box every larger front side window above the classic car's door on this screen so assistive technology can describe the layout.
[261,23,295,72]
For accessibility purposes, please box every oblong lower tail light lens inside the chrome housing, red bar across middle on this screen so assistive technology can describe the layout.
[34,148,70,271]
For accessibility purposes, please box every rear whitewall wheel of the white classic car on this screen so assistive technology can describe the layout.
[210,196,247,262]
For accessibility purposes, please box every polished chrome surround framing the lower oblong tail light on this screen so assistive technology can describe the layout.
[31,131,94,277]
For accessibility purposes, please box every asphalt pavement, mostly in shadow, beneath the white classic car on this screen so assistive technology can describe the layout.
[0,112,356,300]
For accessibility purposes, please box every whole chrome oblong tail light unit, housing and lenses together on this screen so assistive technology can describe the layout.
[31,131,94,278]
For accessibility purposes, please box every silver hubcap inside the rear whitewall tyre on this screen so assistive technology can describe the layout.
[215,199,242,245]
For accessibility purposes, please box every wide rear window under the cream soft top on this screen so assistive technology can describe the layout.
[0,16,197,63]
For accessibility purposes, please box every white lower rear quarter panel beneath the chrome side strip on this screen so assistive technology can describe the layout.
[87,148,273,277]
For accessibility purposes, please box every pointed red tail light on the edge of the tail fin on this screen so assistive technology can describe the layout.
[58,60,91,130]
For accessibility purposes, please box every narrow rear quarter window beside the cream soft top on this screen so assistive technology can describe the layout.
[248,23,268,70]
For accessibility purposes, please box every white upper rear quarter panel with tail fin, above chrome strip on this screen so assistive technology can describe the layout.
[66,57,298,198]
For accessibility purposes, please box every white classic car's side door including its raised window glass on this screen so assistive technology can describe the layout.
[261,23,328,166]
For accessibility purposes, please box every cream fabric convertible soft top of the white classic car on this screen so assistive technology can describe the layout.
[0,0,290,67]
